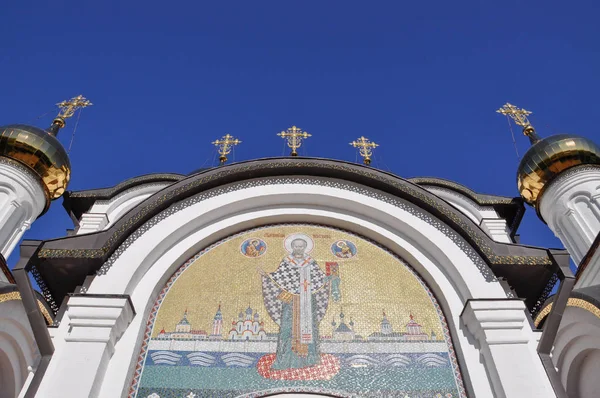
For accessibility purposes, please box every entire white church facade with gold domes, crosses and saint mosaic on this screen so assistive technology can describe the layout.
[0,96,600,398]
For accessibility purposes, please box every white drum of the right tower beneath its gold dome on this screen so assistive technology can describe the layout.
[539,166,600,287]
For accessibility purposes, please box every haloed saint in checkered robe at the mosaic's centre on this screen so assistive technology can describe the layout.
[261,234,331,370]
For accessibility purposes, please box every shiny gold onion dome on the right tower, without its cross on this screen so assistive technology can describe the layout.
[517,134,600,207]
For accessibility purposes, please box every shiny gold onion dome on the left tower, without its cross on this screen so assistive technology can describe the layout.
[0,124,71,200]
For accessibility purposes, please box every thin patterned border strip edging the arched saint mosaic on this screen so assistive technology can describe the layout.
[127,223,467,398]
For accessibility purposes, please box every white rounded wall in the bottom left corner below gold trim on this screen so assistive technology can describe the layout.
[0,298,40,398]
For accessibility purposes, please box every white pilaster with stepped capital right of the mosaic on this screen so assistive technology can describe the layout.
[461,299,556,398]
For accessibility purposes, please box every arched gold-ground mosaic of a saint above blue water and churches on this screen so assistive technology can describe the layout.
[129,224,466,398]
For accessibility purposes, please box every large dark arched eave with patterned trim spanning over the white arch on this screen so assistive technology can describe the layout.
[28,157,556,309]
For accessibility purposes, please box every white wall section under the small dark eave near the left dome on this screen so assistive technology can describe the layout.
[77,183,170,235]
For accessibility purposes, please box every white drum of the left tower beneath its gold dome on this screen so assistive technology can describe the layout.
[0,157,46,258]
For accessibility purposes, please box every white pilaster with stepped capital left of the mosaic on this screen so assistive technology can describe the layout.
[36,294,135,398]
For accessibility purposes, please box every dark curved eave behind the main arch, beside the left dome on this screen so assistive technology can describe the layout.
[63,173,185,220]
